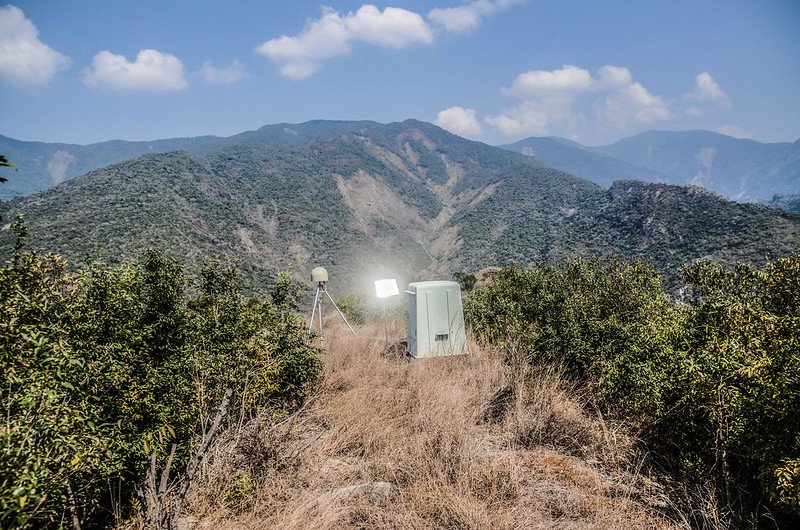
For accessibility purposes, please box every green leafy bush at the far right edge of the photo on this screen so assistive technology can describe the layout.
[680,255,800,516]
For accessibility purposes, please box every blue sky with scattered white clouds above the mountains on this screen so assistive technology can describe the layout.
[0,0,800,145]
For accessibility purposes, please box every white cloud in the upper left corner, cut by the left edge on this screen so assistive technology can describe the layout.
[0,5,71,84]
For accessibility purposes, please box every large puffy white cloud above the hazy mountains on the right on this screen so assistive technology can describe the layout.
[486,65,673,137]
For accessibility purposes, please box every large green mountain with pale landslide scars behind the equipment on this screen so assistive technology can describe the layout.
[0,120,800,294]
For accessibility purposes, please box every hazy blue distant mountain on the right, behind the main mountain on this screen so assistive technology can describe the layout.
[502,131,800,202]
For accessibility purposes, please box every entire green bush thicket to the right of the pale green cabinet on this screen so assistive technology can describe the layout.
[465,255,800,521]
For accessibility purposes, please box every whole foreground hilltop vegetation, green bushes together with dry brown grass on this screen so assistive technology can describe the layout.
[0,220,800,529]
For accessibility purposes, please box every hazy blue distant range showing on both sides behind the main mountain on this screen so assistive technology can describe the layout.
[0,126,800,206]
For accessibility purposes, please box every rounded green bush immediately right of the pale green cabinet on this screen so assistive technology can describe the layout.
[464,261,681,417]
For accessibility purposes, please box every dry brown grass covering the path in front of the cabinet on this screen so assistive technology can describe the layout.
[183,325,678,530]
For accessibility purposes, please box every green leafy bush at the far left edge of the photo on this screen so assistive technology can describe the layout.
[0,250,121,528]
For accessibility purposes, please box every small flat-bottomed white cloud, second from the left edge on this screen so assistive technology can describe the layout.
[83,50,189,91]
